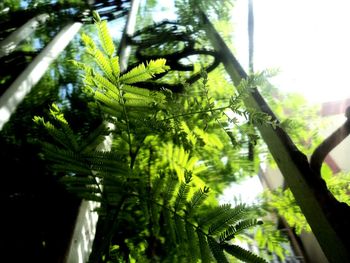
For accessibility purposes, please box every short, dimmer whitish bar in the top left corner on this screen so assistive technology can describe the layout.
[0,14,49,58]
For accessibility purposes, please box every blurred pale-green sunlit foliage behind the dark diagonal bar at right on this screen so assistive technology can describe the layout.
[257,70,350,237]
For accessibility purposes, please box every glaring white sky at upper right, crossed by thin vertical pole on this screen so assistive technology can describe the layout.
[233,0,350,102]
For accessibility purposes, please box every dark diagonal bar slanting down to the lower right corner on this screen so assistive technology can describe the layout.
[200,12,350,263]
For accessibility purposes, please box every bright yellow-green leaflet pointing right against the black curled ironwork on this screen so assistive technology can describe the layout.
[119,59,169,84]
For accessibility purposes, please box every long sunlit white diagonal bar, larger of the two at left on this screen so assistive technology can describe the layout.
[0,22,82,130]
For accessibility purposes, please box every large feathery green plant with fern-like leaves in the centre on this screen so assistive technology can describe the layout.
[34,14,266,262]
